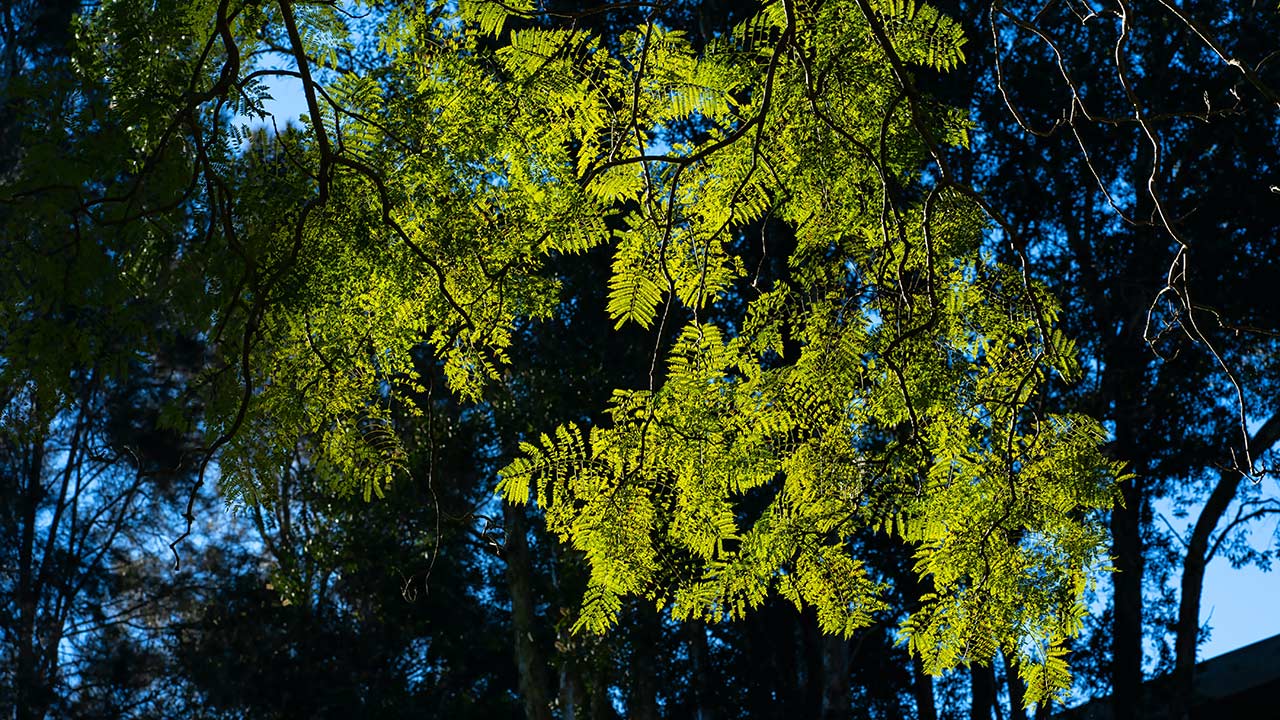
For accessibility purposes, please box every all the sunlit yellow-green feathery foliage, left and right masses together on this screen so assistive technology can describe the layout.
[189,0,1116,702]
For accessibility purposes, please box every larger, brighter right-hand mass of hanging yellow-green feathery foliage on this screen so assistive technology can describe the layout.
[499,1,1117,702]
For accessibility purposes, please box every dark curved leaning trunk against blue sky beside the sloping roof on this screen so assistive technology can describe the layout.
[1169,413,1280,720]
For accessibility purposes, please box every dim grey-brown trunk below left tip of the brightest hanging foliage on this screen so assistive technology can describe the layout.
[502,502,563,720]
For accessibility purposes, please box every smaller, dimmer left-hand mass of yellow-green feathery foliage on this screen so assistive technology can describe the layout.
[212,8,609,501]
